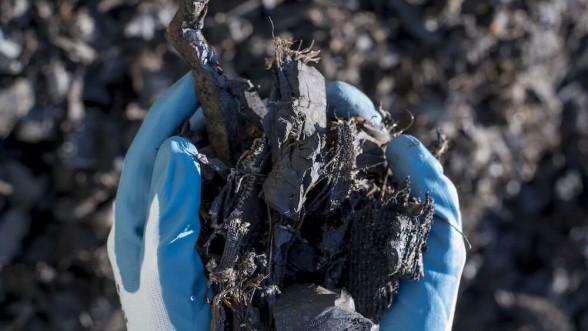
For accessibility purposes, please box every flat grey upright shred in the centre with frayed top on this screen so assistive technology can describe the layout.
[263,39,327,226]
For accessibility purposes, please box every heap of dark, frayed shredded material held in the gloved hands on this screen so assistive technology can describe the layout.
[168,0,433,330]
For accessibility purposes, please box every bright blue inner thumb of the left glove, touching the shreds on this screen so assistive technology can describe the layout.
[141,137,211,330]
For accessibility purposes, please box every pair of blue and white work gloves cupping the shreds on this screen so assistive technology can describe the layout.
[108,74,466,331]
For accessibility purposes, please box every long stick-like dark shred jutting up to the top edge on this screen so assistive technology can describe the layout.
[167,0,267,165]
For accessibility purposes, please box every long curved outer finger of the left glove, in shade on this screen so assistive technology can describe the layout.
[111,73,198,292]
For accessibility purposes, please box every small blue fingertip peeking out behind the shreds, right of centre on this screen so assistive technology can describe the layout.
[327,81,382,125]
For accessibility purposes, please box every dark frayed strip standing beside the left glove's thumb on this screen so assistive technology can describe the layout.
[204,138,269,325]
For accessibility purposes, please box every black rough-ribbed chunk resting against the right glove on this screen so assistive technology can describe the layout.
[343,183,433,322]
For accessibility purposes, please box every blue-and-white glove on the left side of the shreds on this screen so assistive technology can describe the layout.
[108,74,211,330]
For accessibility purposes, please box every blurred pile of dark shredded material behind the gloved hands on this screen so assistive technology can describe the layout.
[0,0,588,331]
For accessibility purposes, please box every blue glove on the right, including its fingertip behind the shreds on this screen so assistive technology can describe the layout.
[327,82,466,331]
